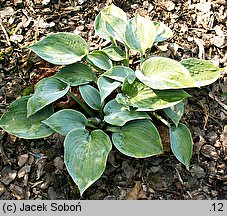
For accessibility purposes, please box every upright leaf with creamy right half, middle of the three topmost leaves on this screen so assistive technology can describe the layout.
[125,15,156,54]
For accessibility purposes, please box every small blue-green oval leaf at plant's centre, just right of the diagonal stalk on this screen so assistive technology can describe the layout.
[79,85,103,110]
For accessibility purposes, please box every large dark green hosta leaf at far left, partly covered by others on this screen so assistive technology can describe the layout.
[0,96,54,139]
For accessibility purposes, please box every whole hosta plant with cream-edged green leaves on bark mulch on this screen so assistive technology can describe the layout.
[0,5,220,195]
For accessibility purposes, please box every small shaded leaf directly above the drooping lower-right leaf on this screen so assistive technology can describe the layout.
[163,101,184,127]
